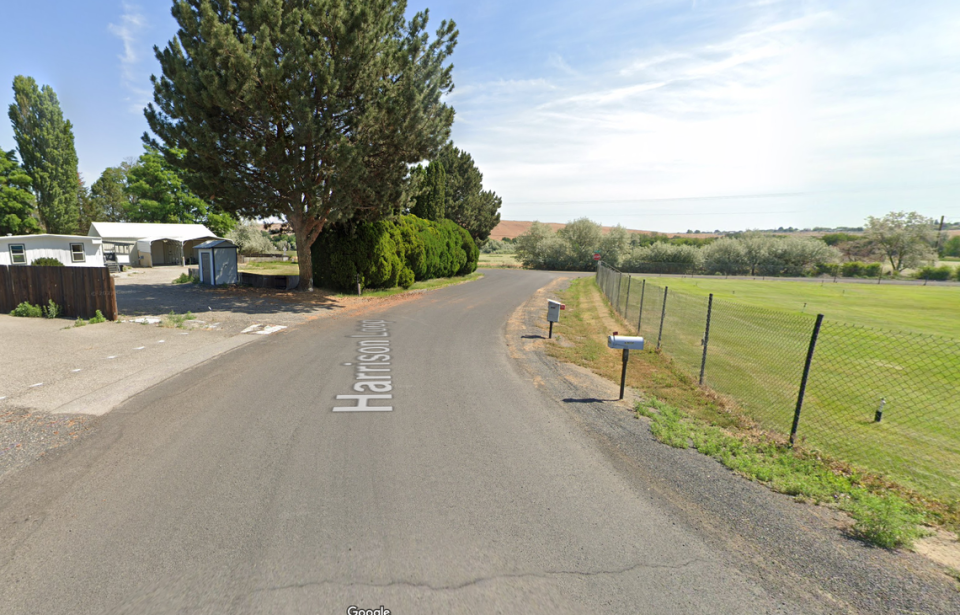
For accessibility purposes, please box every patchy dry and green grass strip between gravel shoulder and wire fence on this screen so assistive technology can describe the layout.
[547,278,960,549]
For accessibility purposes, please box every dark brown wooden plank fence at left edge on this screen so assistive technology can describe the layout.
[0,265,117,320]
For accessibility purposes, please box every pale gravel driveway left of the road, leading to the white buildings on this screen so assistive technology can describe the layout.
[0,267,369,477]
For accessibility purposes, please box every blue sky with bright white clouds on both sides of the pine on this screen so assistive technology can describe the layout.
[0,0,960,232]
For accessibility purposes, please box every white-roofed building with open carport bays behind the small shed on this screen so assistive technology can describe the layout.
[87,222,217,267]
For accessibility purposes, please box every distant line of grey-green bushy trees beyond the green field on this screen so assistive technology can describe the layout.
[512,212,948,279]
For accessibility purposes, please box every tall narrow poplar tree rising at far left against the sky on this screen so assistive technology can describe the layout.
[10,75,80,235]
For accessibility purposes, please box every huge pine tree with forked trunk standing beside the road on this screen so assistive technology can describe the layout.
[144,0,457,290]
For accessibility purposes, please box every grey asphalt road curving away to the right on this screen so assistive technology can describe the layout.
[0,271,816,614]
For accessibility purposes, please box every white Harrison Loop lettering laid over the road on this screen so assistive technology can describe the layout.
[333,320,393,412]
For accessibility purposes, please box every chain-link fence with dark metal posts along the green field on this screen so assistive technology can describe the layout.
[597,263,960,499]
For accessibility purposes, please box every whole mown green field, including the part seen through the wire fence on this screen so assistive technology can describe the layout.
[601,274,960,499]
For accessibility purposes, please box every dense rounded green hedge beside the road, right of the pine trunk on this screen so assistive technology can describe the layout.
[313,215,480,291]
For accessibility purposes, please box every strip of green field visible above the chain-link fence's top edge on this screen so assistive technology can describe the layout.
[632,274,960,339]
